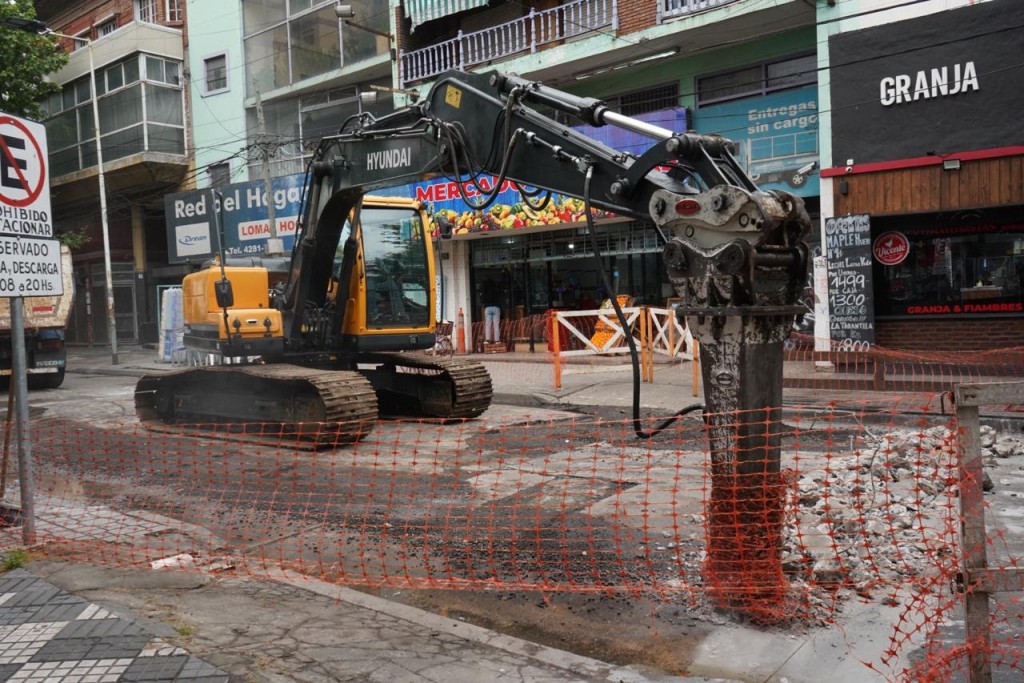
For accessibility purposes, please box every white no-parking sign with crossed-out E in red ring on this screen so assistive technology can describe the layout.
[0,113,53,238]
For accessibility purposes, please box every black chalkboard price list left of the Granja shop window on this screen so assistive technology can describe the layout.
[825,215,874,351]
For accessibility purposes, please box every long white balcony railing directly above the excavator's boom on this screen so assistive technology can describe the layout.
[400,0,616,87]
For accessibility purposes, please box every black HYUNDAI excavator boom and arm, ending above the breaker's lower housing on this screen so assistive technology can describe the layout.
[283,72,809,348]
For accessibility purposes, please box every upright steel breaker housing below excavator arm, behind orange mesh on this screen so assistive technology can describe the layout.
[693,311,793,620]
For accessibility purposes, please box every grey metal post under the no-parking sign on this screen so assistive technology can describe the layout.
[10,297,36,546]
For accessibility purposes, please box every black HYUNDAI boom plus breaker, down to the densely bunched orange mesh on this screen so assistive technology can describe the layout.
[282,72,810,470]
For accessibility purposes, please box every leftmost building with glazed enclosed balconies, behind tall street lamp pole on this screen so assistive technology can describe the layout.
[35,0,190,344]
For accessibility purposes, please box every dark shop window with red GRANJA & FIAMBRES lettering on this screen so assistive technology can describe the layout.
[873,224,1024,317]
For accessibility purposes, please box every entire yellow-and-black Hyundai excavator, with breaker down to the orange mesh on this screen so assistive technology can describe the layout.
[135,72,810,447]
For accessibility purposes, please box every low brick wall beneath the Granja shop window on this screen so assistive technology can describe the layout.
[874,317,1024,351]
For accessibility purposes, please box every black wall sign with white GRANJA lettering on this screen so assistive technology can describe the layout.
[828,0,1024,169]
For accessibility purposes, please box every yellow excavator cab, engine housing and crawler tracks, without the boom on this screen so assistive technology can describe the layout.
[135,197,492,447]
